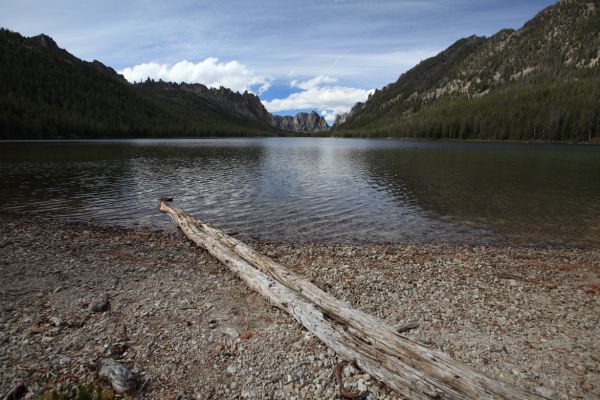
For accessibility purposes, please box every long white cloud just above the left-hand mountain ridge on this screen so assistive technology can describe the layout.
[119,57,272,94]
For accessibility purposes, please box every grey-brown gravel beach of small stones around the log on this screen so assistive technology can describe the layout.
[0,215,600,399]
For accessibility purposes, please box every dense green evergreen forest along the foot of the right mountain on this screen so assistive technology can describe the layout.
[334,75,600,142]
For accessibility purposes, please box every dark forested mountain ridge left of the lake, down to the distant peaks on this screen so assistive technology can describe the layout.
[0,29,326,139]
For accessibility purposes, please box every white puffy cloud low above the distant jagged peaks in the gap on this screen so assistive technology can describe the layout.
[263,79,374,124]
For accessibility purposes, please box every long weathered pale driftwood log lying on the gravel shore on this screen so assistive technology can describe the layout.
[160,201,544,399]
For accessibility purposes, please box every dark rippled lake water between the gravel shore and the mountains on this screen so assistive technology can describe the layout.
[0,138,600,246]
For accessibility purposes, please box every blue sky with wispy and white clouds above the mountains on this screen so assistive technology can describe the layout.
[0,0,554,122]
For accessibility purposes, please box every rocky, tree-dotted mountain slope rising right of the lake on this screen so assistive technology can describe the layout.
[333,0,600,141]
